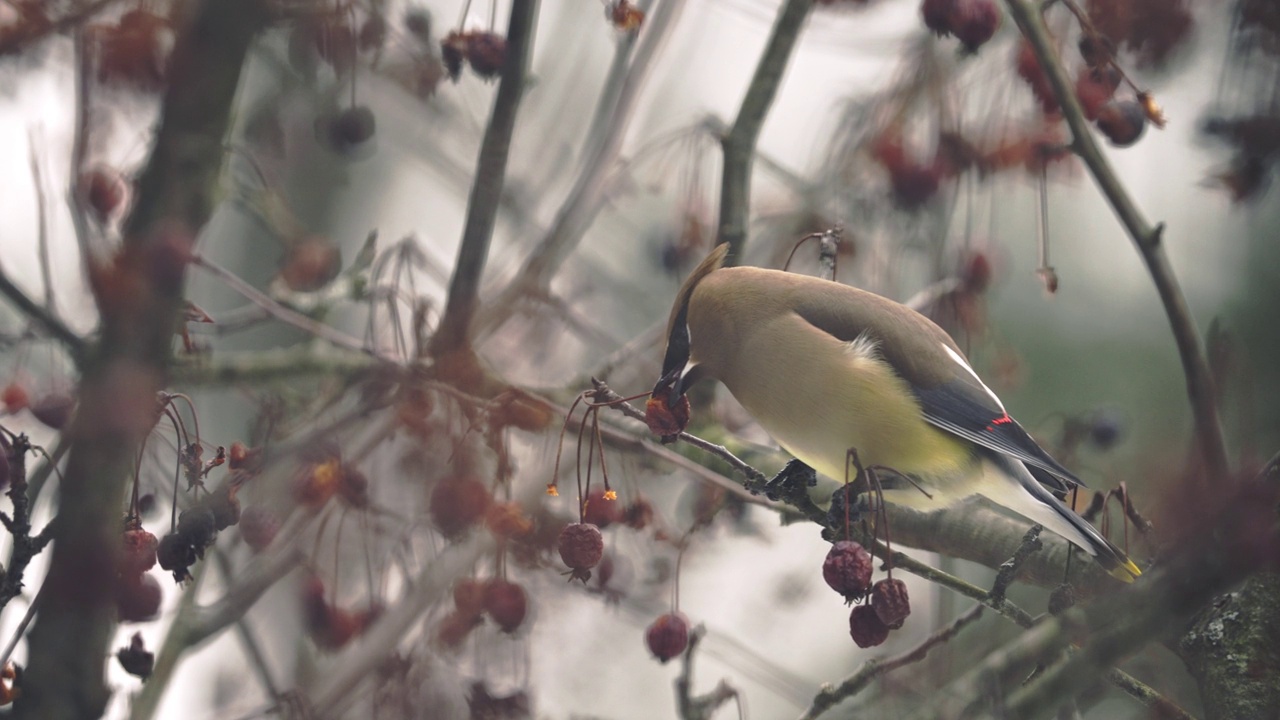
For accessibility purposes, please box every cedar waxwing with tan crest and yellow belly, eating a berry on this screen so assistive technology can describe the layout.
[654,245,1140,582]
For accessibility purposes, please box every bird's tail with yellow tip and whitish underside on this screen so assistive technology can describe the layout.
[983,452,1142,583]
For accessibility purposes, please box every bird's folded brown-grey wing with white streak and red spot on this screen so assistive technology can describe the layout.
[795,281,1084,493]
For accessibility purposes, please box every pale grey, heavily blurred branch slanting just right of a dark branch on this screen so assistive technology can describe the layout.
[476,0,685,333]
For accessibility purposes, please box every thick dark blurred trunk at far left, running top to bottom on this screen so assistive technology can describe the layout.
[14,0,266,720]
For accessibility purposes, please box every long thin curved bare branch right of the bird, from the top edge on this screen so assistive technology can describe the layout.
[1005,0,1229,484]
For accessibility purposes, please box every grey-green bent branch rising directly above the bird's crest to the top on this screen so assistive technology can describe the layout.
[716,0,813,263]
